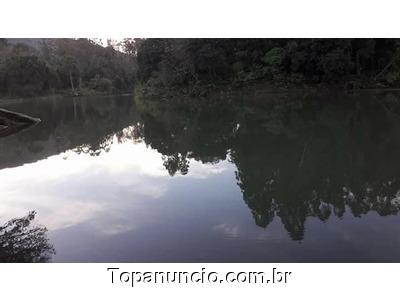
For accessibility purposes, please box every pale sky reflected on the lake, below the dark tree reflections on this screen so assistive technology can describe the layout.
[0,135,400,262]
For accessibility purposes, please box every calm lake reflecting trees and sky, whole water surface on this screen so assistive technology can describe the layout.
[0,89,400,262]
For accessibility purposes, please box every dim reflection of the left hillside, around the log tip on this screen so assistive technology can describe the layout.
[0,96,137,169]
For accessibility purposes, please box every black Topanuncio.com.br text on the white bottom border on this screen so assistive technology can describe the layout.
[107,267,292,287]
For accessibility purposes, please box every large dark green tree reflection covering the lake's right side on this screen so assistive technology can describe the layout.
[135,92,400,240]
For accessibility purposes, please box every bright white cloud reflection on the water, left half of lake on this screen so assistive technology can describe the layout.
[0,138,231,234]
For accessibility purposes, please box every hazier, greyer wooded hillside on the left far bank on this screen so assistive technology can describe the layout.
[0,39,136,96]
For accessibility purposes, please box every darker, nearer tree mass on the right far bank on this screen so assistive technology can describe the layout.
[135,39,400,92]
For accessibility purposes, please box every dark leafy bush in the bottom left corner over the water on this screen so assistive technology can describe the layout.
[0,211,55,262]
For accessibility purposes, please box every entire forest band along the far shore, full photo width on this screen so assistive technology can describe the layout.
[0,38,400,97]
